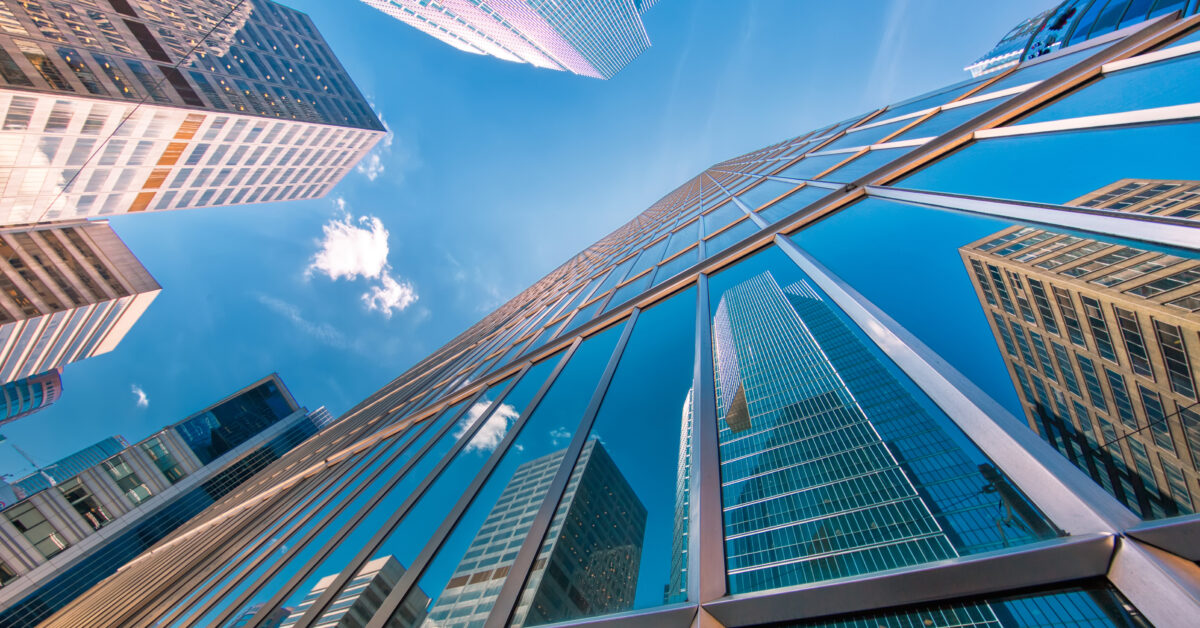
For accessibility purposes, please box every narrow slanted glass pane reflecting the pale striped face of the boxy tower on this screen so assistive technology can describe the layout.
[395,325,624,628]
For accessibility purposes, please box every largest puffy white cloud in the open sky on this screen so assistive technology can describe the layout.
[305,198,418,318]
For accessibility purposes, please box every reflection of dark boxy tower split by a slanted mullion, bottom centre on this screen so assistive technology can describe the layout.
[430,438,646,628]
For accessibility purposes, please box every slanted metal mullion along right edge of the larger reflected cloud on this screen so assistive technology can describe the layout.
[350,336,583,628]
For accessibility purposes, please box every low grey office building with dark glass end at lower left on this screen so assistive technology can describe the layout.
[0,375,328,626]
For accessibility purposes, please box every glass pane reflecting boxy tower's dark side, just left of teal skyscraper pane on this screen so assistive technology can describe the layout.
[512,288,696,626]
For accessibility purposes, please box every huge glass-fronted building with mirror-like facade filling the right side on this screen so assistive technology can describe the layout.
[25,8,1200,628]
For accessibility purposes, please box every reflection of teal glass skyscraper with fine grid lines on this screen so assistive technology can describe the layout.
[713,273,1050,593]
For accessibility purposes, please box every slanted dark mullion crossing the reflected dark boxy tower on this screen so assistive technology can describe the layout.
[482,307,641,628]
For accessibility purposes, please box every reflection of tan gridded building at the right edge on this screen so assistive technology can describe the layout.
[960,183,1200,518]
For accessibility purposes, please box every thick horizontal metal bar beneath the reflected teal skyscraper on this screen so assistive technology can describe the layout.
[702,534,1116,628]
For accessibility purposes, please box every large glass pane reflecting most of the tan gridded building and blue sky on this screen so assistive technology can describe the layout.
[794,199,1200,518]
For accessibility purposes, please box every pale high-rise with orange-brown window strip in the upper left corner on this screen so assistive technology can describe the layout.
[0,0,384,225]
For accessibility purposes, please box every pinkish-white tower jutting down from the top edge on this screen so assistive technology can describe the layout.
[362,0,654,78]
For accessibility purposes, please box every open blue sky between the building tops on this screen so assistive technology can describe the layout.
[0,0,1050,477]
